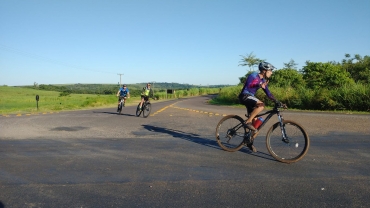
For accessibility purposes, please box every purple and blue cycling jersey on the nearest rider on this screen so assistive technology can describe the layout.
[241,72,276,100]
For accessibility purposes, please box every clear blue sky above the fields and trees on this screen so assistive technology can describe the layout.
[0,0,370,86]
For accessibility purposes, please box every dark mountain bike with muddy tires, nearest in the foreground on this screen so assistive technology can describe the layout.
[216,102,310,163]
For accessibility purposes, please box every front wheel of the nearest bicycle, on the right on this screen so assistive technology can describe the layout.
[266,120,310,163]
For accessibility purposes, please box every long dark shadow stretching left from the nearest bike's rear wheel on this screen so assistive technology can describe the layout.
[142,125,221,150]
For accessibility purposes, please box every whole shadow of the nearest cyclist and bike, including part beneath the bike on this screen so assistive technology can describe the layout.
[142,124,278,162]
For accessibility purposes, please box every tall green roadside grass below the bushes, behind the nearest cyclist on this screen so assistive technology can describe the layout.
[212,83,370,111]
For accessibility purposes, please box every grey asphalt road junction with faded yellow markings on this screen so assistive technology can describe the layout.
[0,96,370,207]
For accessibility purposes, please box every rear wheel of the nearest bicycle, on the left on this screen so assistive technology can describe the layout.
[216,115,246,152]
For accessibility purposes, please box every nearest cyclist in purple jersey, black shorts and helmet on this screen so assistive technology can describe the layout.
[239,62,276,131]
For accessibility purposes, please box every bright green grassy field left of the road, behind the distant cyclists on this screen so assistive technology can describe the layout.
[0,86,219,115]
